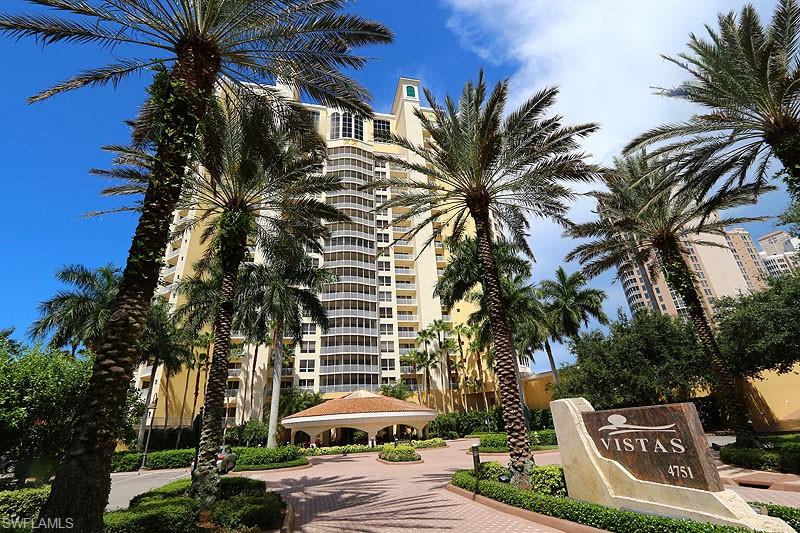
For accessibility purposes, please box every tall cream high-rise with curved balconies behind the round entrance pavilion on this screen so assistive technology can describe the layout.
[135,78,530,426]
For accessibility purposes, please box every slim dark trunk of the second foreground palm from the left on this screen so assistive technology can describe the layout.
[190,230,247,505]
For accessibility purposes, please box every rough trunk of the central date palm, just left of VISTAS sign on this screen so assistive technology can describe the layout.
[471,209,533,474]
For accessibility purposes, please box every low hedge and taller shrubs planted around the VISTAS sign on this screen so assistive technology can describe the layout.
[451,463,800,533]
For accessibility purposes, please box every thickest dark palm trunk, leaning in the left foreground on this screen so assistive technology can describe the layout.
[40,54,220,533]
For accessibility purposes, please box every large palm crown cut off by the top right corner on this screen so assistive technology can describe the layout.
[625,0,800,198]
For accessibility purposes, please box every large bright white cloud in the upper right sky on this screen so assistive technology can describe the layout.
[442,0,773,369]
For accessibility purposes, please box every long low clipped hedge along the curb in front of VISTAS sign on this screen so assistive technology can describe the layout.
[452,470,750,533]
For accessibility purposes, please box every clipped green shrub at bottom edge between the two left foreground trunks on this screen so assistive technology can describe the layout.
[103,497,201,533]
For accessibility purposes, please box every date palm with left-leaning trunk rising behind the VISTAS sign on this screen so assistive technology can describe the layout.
[567,154,763,444]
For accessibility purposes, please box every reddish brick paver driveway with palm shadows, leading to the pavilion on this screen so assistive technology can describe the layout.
[249,440,558,533]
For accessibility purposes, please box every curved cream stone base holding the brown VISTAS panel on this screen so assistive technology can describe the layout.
[550,398,794,533]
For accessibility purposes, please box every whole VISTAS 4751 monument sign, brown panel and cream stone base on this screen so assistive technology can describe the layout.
[550,398,794,533]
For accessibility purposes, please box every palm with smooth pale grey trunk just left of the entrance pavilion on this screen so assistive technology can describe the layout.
[241,254,337,448]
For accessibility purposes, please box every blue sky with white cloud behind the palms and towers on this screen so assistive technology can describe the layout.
[0,0,784,369]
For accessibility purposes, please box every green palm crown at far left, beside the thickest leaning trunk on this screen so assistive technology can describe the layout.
[28,263,120,355]
